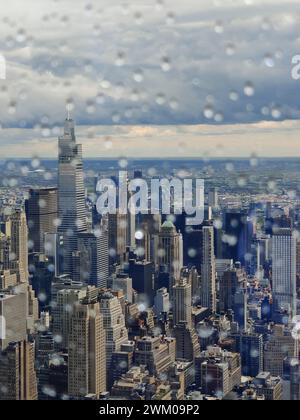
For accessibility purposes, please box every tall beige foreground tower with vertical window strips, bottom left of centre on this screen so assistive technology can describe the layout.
[68,302,106,398]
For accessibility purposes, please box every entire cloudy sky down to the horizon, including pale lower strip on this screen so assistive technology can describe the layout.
[0,0,300,158]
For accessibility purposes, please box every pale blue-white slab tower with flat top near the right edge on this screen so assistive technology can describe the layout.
[272,228,297,317]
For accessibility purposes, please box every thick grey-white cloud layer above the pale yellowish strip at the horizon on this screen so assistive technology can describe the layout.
[0,0,300,153]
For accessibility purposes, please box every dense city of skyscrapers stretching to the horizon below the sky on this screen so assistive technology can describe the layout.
[0,116,300,401]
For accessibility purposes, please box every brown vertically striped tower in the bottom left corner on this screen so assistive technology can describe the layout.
[0,340,38,401]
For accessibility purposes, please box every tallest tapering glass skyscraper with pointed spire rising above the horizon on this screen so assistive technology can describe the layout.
[58,115,87,275]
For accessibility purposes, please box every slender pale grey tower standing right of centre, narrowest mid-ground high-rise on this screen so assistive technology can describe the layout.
[201,226,217,313]
